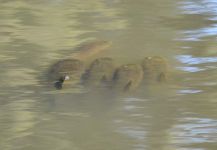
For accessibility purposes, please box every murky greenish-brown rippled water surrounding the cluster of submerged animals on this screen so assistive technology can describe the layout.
[0,0,217,150]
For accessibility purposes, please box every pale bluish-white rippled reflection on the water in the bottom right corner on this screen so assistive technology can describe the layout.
[173,118,217,144]
